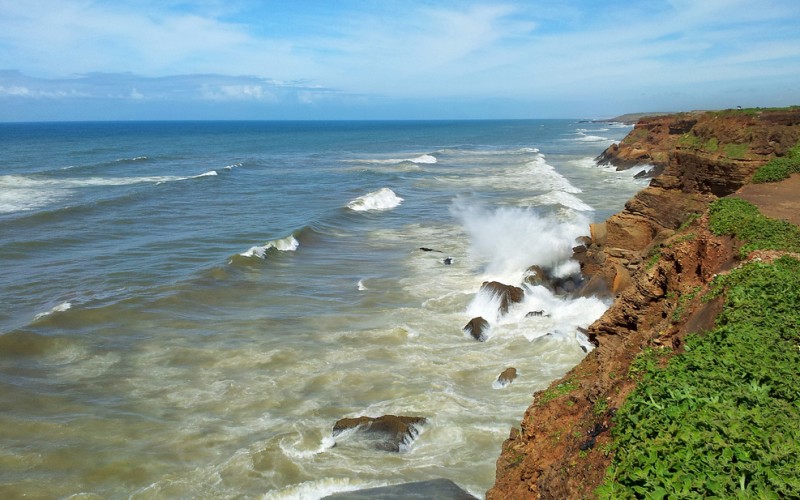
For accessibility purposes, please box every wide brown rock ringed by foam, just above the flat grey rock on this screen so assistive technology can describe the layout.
[332,415,427,452]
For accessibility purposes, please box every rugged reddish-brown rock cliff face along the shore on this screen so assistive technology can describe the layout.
[487,108,800,499]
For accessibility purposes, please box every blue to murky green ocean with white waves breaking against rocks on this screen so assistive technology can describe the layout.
[0,120,647,499]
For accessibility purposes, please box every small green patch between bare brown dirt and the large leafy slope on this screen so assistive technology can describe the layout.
[709,198,800,256]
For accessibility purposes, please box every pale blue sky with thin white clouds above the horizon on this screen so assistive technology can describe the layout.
[0,0,800,121]
